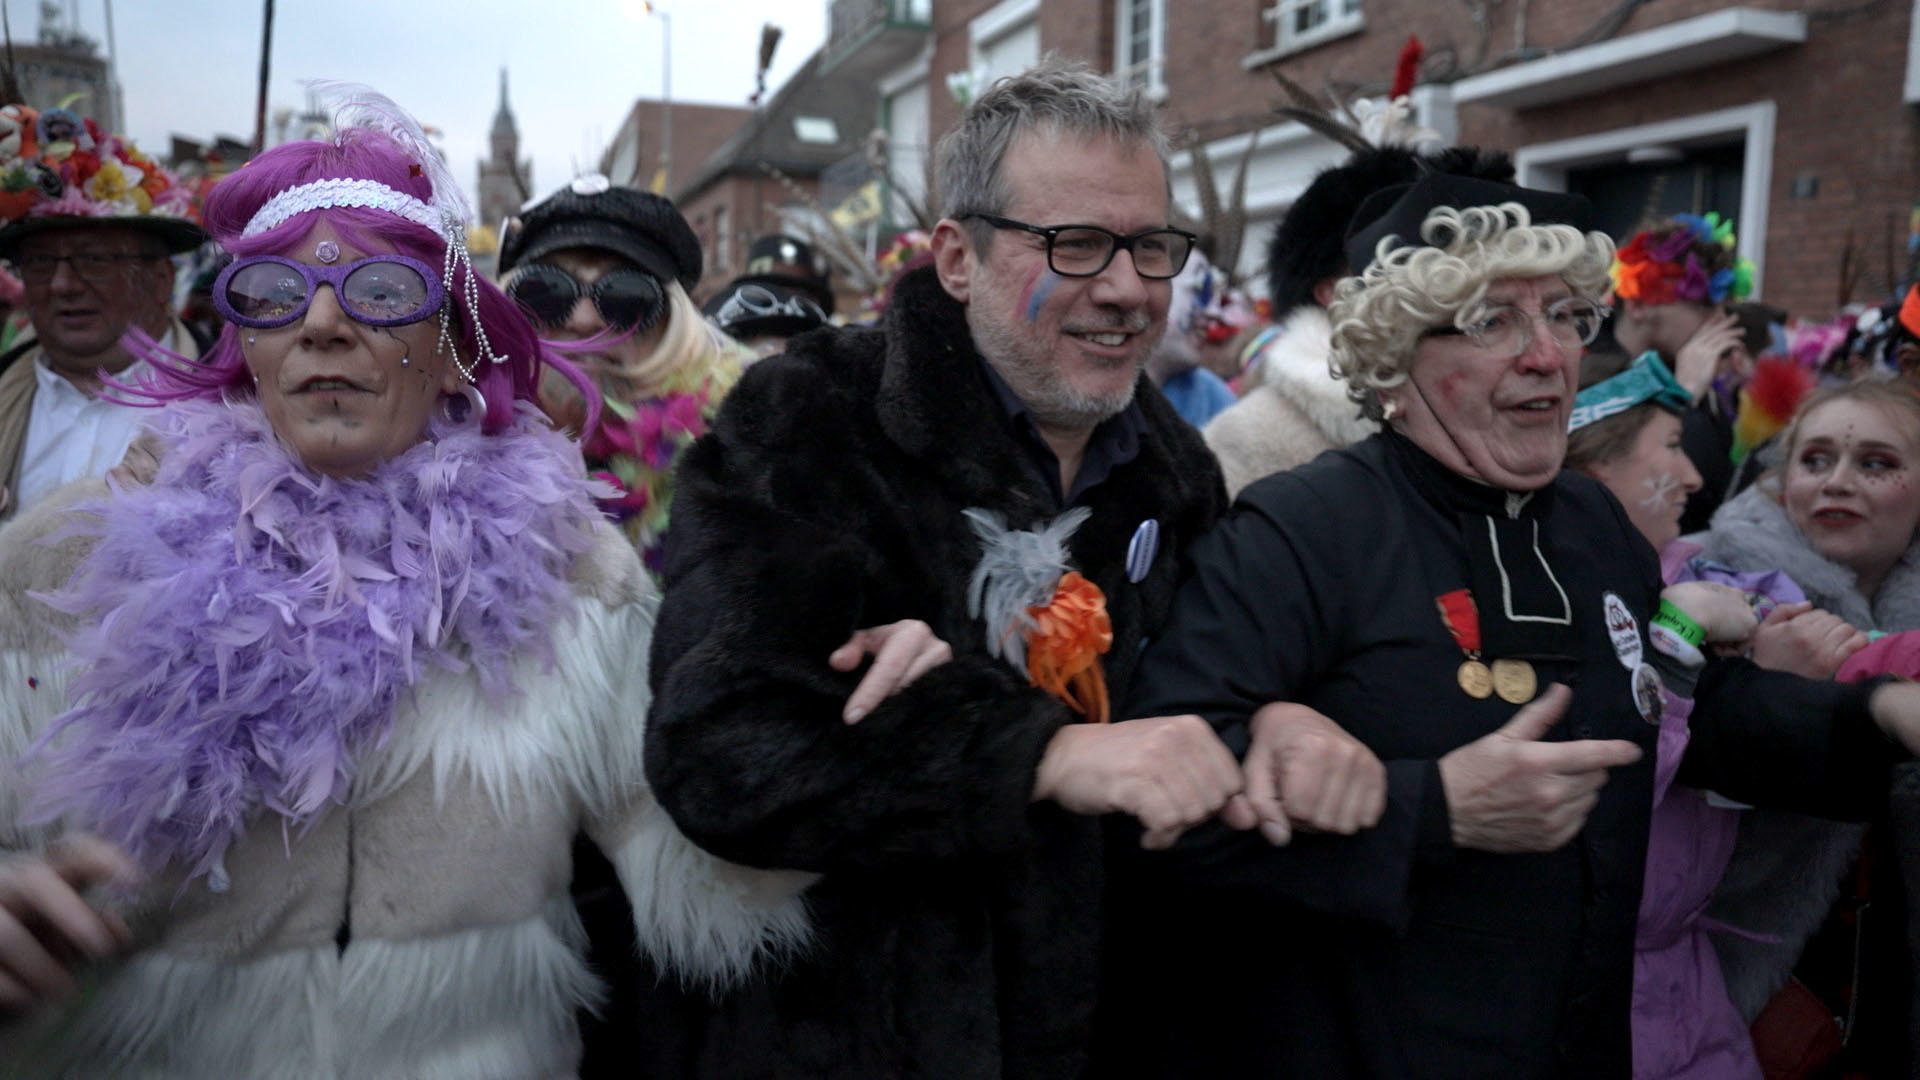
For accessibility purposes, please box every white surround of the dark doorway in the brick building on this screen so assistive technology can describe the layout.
[1513,102,1780,296]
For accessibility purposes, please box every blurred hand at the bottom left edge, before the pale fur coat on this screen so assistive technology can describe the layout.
[0,836,140,1011]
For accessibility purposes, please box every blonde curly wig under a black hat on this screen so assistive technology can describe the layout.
[1327,202,1613,419]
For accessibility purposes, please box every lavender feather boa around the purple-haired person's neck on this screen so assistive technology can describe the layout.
[27,402,599,890]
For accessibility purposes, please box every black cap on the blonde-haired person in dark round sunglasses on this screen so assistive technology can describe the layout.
[499,177,701,290]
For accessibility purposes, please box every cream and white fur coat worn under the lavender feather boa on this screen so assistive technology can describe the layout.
[0,482,812,1080]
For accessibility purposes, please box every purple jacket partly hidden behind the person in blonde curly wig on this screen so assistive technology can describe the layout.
[1634,540,1805,1080]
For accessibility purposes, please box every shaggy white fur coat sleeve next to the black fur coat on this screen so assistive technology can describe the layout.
[563,528,816,986]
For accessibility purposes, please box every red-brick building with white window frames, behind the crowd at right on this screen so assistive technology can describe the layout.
[867,0,1920,317]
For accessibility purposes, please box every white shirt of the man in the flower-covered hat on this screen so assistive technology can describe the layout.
[13,327,175,509]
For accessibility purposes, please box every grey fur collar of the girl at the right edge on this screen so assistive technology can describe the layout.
[1690,484,1920,632]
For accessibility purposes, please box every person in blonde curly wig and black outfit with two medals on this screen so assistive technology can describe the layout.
[1125,175,1920,1080]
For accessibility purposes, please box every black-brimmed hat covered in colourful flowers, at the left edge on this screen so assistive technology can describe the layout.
[0,104,207,258]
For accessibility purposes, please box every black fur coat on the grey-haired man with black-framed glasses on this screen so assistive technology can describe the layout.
[647,269,1225,1080]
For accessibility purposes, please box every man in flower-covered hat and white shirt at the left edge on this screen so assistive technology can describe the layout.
[0,117,205,519]
